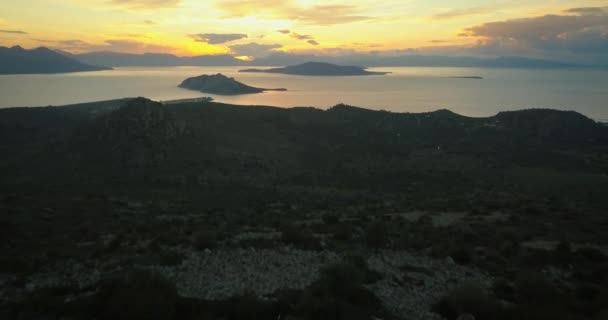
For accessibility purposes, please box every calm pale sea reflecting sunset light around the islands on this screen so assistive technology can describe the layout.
[0,67,608,120]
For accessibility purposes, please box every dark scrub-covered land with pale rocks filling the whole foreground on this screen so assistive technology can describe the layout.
[0,98,608,320]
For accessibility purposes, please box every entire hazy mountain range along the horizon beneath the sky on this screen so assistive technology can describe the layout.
[0,46,590,74]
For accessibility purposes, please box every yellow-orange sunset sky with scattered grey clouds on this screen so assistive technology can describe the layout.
[0,0,608,63]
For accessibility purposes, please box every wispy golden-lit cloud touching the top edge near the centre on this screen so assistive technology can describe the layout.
[216,0,371,25]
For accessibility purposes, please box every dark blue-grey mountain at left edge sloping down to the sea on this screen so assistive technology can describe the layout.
[0,46,110,74]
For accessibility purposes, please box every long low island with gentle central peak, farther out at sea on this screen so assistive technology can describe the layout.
[239,62,390,76]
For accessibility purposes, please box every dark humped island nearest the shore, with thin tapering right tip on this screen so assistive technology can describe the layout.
[178,73,287,96]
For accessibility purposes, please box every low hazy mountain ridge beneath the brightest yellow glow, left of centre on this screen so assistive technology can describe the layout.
[72,52,246,67]
